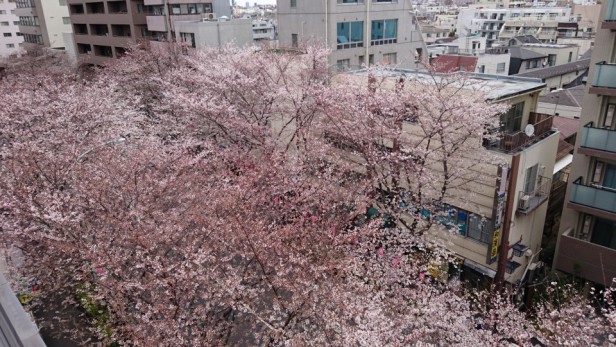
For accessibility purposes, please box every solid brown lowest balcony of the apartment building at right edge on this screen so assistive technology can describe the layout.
[554,228,616,286]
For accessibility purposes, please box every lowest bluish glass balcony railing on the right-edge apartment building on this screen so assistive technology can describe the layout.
[570,177,616,213]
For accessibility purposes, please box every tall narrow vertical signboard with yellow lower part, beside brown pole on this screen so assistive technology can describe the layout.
[486,163,509,264]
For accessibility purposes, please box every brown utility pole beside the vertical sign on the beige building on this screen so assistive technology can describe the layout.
[494,152,520,292]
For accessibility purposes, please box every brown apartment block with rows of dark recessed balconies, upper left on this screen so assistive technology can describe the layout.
[68,0,148,65]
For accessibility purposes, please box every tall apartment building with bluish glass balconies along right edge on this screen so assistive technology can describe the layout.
[554,0,616,286]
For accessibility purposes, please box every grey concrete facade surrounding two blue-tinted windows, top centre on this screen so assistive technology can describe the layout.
[278,1,427,68]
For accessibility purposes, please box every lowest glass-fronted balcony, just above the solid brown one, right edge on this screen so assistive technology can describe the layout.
[567,177,616,219]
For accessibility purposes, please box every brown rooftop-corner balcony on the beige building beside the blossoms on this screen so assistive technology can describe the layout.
[484,112,554,154]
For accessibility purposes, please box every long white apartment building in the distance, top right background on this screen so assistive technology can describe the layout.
[457,7,571,47]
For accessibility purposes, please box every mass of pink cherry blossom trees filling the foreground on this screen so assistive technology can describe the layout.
[0,47,614,346]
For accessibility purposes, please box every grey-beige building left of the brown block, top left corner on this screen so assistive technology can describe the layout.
[15,0,71,49]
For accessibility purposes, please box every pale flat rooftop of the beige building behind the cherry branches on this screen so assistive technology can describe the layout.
[348,69,545,101]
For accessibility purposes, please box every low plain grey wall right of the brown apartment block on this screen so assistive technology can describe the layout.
[175,19,253,48]
